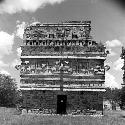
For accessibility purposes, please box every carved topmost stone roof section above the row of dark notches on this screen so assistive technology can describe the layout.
[23,21,91,40]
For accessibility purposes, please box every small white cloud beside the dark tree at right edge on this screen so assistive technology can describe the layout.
[113,57,124,71]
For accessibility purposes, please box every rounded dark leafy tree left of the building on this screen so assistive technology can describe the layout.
[0,74,18,107]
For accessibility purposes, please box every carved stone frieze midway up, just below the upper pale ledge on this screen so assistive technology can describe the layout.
[20,60,105,76]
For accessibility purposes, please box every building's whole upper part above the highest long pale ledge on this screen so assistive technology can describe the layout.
[21,21,107,58]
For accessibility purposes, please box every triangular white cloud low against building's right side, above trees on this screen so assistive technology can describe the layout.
[105,72,121,88]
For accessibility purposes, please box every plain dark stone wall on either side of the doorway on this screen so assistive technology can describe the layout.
[22,90,103,111]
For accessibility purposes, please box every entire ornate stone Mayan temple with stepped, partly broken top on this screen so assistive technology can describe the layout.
[16,21,107,114]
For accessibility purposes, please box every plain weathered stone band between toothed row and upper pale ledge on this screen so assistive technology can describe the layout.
[21,43,106,56]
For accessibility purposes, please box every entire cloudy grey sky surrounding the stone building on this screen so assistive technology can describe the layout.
[0,0,125,88]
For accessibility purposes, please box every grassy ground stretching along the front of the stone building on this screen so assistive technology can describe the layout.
[0,107,125,125]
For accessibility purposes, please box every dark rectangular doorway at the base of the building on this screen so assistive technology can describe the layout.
[57,95,67,114]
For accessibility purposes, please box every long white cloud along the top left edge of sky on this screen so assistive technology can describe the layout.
[0,0,64,14]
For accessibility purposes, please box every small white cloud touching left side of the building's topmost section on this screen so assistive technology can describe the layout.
[16,21,26,39]
